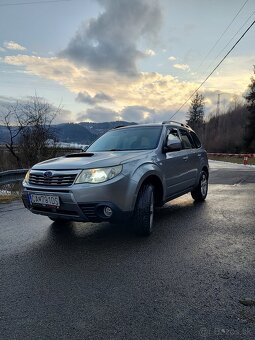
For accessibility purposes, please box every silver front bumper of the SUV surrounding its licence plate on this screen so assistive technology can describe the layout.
[22,176,133,222]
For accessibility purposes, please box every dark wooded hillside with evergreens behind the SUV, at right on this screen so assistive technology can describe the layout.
[187,69,255,153]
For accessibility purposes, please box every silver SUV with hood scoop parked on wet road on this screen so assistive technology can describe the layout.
[22,122,209,235]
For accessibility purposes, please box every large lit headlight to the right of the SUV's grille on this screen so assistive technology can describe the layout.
[75,165,122,183]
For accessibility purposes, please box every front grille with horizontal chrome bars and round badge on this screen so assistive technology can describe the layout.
[29,173,77,186]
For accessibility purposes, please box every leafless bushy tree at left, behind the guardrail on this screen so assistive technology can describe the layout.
[0,95,61,167]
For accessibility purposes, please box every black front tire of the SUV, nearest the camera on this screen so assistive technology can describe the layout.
[133,184,155,236]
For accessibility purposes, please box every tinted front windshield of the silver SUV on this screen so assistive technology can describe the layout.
[87,126,162,152]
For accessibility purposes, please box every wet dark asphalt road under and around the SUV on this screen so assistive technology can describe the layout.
[0,162,255,340]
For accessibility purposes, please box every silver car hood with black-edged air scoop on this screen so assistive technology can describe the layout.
[32,150,151,170]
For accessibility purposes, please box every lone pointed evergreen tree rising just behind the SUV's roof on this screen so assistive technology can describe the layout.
[187,92,204,130]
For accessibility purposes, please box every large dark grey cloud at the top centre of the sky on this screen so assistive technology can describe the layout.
[59,0,161,76]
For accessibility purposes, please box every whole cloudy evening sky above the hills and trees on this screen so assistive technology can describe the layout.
[0,0,255,123]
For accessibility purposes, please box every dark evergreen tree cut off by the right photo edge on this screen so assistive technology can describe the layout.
[244,66,255,152]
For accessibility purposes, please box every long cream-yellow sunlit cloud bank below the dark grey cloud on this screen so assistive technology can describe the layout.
[4,55,196,111]
